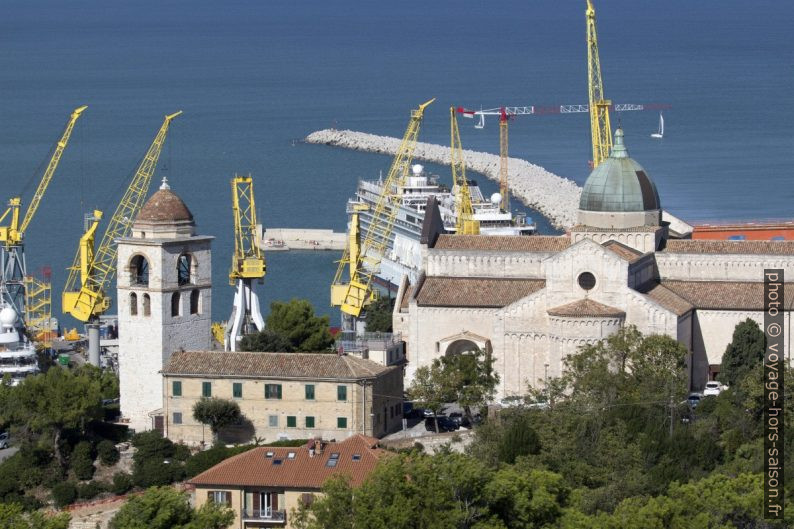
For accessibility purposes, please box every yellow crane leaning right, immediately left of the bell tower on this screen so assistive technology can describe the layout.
[61,110,182,363]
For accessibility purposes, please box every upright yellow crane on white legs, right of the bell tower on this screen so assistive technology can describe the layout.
[224,174,267,351]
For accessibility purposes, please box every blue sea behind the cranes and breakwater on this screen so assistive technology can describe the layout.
[0,0,794,324]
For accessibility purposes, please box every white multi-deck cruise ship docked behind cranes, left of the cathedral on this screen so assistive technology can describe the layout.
[347,164,535,290]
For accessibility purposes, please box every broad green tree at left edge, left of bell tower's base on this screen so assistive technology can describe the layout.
[0,368,102,466]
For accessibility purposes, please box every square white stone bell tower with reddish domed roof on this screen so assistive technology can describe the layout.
[116,178,214,432]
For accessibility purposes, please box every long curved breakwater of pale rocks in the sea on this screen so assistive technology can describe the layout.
[305,129,582,229]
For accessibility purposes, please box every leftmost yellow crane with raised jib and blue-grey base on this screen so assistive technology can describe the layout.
[0,106,88,325]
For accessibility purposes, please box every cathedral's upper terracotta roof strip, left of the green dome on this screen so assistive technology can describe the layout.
[433,235,571,252]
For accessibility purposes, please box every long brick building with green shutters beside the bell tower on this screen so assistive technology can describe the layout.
[162,351,403,444]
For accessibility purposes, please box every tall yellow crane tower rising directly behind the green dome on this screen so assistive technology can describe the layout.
[585,0,612,168]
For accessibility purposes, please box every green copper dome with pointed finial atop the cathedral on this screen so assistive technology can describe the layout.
[579,129,661,212]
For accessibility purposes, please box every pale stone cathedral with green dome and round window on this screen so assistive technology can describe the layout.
[393,129,794,398]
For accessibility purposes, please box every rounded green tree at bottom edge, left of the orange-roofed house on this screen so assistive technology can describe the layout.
[109,487,234,529]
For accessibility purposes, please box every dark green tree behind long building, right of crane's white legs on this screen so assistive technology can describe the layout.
[265,299,334,352]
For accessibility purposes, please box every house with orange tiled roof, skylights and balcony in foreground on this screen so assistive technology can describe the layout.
[188,436,389,529]
